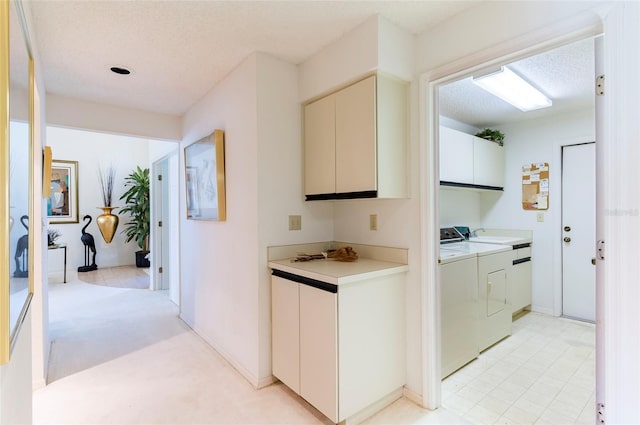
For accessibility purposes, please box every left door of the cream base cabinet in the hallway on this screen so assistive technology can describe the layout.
[271,276,300,394]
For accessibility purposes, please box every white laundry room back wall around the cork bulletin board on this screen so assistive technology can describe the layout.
[481,108,595,315]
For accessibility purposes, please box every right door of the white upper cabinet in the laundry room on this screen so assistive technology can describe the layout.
[473,136,504,187]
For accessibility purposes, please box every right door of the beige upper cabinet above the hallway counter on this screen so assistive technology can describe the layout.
[335,77,377,193]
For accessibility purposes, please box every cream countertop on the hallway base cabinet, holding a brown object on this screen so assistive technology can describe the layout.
[269,258,409,286]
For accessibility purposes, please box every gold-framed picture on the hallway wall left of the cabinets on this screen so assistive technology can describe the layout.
[184,130,227,221]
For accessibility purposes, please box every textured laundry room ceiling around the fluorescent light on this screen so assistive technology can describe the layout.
[439,39,595,128]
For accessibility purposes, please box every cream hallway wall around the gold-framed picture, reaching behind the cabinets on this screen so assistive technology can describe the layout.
[180,53,333,386]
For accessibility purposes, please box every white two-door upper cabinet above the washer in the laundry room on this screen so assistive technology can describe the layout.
[439,126,504,190]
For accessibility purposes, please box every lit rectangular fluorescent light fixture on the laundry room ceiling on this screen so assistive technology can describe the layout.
[473,66,552,112]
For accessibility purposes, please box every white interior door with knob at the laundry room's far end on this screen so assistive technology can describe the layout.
[561,143,596,322]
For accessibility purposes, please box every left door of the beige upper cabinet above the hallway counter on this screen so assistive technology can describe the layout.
[304,95,336,195]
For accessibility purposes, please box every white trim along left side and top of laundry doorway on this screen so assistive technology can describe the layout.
[418,12,602,409]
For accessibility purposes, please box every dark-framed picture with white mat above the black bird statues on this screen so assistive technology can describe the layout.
[47,159,78,224]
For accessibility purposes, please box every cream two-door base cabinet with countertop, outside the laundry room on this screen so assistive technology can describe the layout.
[269,259,407,423]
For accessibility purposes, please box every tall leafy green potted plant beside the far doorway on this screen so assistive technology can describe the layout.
[119,166,151,267]
